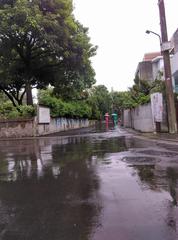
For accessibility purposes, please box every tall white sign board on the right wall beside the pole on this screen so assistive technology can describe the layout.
[151,93,163,122]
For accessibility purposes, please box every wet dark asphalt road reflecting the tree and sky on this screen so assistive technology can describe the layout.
[0,124,178,240]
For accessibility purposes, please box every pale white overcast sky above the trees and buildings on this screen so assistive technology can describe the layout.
[73,0,178,91]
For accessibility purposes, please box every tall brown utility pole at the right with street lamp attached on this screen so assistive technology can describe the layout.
[158,0,177,133]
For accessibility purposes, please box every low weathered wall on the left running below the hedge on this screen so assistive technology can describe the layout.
[0,118,94,138]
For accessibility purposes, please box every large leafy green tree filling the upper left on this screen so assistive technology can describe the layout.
[0,0,96,105]
